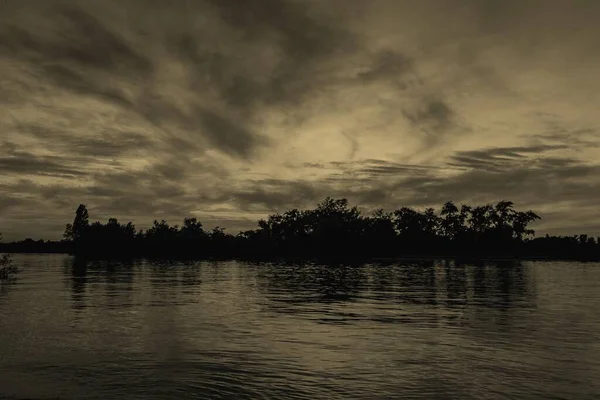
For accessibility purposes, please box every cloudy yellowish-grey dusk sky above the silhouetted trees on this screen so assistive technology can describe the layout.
[0,0,600,240]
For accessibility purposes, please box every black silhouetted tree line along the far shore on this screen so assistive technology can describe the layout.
[48,197,600,259]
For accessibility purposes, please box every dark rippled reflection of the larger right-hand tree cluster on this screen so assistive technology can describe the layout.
[257,261,534,323]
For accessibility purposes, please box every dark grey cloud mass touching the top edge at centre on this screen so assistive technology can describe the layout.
[167,0,358,112]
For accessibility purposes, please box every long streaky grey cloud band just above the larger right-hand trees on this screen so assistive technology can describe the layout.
[213,151,600,231]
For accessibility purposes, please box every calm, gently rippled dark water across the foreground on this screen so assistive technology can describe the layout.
[0,255,600,400]
